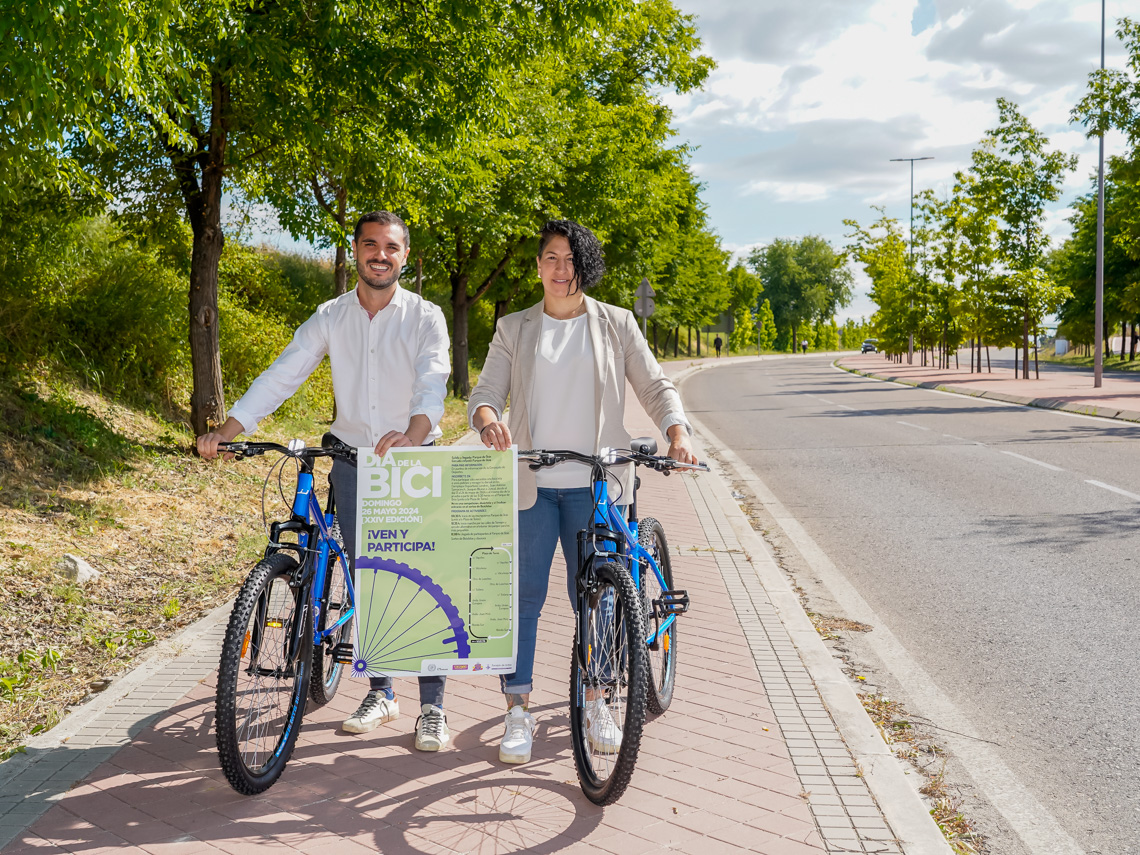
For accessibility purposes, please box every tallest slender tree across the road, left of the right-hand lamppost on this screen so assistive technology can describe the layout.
[970,98,1077,378]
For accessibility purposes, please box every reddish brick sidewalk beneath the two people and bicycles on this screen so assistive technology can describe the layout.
[0,371,950,855]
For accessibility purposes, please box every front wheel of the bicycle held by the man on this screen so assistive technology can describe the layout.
[214,553,312,796]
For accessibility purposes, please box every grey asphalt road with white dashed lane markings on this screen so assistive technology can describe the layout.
[684,357,1140,853]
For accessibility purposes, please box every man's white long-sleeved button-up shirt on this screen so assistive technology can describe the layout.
[229,285,450,447]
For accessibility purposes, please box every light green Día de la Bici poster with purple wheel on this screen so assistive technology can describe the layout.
[352,448,519,677]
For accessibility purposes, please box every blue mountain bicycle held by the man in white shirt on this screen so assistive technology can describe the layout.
[214,434,356,796]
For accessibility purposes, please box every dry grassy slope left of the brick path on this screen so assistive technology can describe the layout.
[0,378,465,759]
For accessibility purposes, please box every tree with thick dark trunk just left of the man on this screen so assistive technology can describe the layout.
[51,0,629,432]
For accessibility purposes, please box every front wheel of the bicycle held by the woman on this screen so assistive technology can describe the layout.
[570,562,646,805]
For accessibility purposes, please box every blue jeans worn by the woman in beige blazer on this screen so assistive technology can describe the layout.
[503,487,594,694]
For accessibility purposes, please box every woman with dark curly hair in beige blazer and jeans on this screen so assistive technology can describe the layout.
[467,220,697,763]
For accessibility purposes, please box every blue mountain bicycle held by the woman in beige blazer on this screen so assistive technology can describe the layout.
[519,439,708,805]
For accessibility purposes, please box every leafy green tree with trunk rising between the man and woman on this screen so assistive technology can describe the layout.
[413,0,711,397]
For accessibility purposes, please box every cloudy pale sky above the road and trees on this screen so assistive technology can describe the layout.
[663,0,1140,320]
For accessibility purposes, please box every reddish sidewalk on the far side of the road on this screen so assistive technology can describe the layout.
[837,353,1140,422]
